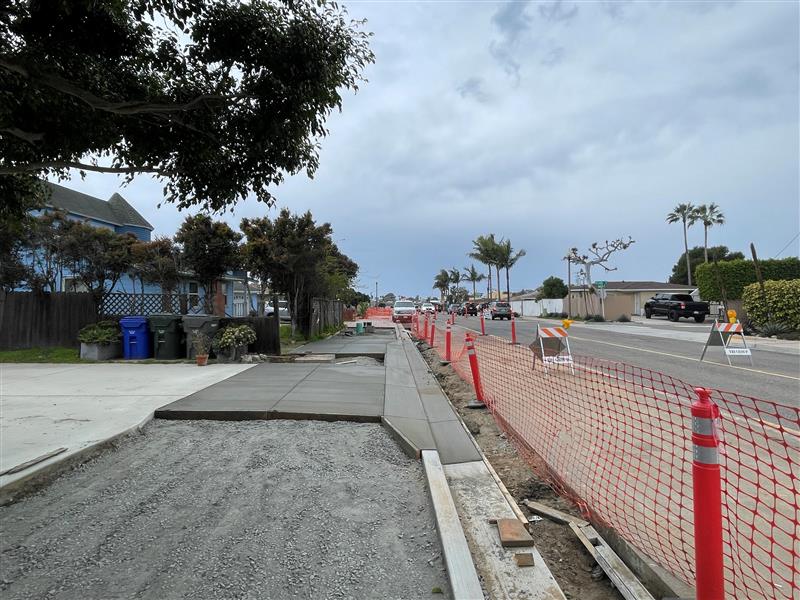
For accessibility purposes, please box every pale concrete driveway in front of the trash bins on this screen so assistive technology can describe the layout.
[0,363,252,487]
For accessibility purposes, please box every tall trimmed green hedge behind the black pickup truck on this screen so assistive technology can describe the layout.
[695,256,800,301]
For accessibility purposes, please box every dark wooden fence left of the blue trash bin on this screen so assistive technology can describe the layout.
[0,291,97,350]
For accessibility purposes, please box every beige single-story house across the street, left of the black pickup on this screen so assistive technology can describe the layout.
[565,281,697,319]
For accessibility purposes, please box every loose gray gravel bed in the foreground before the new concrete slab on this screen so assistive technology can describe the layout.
[0,421,450,600]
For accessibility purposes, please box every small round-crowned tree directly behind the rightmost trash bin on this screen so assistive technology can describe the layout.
[175,214,242,314]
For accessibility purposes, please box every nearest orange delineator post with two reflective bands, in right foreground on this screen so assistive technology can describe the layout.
[692,388,725,600]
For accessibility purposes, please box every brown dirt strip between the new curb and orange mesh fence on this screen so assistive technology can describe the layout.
[420,344,622,600]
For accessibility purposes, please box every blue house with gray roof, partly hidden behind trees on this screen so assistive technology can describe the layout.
[24,182,250,316]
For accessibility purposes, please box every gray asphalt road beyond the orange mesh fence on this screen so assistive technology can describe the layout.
[456,317,800,406]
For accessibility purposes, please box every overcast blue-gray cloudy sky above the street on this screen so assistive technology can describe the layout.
[57,0,800,295]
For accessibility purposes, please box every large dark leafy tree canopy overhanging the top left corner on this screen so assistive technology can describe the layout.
[0,0,374,210]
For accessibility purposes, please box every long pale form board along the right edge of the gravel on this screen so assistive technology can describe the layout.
[422,450,483,600]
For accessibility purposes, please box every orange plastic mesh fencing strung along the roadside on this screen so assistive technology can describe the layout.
[412,316,800,599]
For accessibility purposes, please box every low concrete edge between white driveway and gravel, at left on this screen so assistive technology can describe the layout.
[0,411,155,506]
